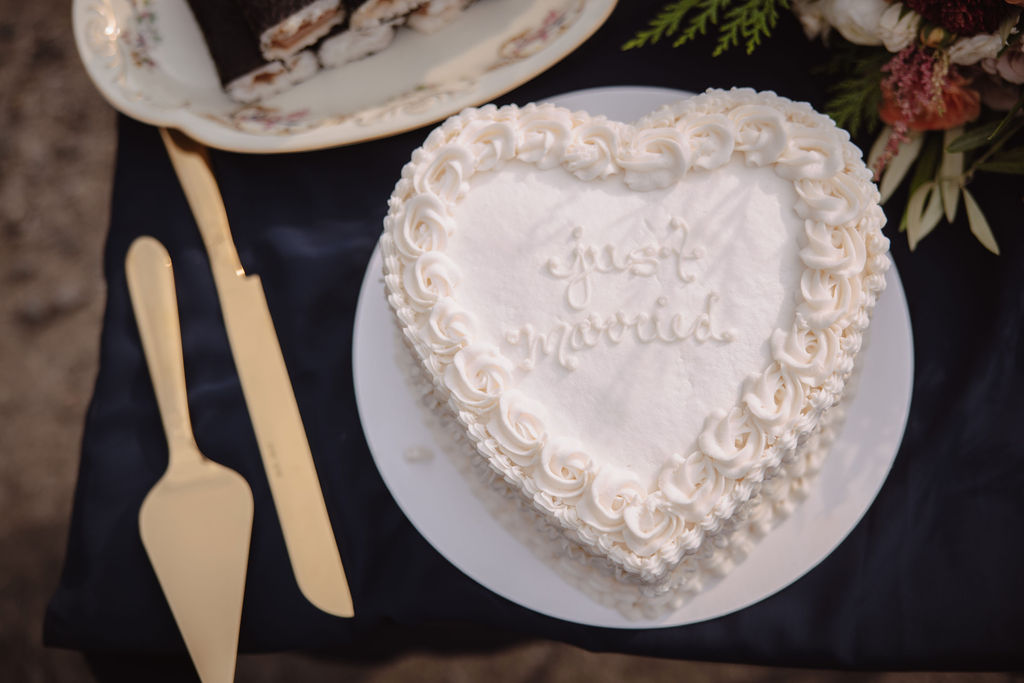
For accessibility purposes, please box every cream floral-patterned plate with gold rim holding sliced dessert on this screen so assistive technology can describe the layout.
[72,0,615,154]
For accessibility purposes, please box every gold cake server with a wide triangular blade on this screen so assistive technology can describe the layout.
[125,238,253,683]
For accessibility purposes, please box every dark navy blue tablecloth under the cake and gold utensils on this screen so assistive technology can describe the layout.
[45,2,1024,669]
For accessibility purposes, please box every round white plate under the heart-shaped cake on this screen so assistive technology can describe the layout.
[352,87,913,629]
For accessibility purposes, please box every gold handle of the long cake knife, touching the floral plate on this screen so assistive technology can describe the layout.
[160,128,244,280]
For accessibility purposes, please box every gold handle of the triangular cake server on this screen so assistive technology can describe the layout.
[125,236,198,465]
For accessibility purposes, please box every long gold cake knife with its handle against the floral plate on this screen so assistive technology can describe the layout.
[160,129,354,616]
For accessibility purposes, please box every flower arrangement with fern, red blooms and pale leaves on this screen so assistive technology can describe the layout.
[624,0,1024,254]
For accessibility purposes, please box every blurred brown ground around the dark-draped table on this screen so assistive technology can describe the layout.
[0,0,1024,683]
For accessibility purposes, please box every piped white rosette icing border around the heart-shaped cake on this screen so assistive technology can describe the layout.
[381,89,889,582]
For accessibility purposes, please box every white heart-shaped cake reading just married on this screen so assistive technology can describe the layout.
[381,90,889,618]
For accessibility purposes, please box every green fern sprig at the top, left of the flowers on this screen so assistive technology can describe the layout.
[623,0,788,56]
